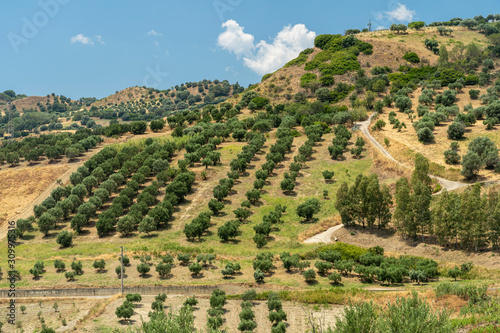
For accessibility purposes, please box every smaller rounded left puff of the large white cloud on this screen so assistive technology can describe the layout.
[217,20,255,57]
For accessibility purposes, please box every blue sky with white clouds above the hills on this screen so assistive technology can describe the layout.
[0,0,500,99]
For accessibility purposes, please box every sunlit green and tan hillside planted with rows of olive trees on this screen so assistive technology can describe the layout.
[0,16,500,333]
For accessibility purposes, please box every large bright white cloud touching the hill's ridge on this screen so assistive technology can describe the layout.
[218,20,316,75]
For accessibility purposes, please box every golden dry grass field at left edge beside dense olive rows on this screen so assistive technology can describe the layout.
[0,165,69,225]
